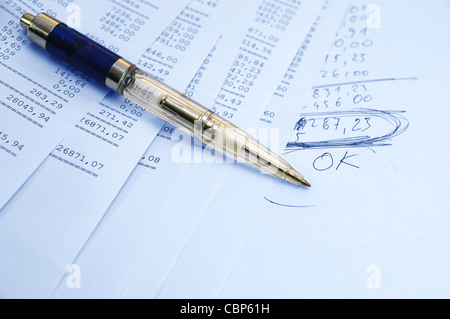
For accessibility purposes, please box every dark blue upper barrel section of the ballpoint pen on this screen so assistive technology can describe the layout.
[45,23,121,83]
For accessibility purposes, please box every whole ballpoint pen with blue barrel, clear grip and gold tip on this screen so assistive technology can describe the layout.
[20,13,311,187]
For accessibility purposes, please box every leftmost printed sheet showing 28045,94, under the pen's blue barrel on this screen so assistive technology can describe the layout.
[0,0,188,209]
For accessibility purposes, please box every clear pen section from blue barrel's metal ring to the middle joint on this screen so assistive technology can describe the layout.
[122,70,208,135]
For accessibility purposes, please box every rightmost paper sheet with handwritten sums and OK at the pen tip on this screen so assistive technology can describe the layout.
[155,0,450,298]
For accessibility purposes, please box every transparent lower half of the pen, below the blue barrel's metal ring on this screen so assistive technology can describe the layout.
[122,70,291,178]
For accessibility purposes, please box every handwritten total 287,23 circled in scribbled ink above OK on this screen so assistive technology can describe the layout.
[286,109,409,154]
